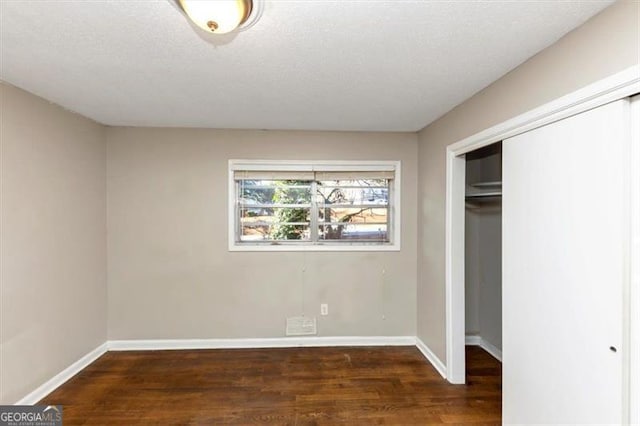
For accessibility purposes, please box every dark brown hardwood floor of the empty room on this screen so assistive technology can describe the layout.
[40,347,501,425]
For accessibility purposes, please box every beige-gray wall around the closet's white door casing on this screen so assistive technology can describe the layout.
[417,1,640,361]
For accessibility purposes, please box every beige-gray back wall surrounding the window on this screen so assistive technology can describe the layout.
[107,128,417,339]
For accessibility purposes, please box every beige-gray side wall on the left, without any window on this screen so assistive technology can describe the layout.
[0,84,107,404]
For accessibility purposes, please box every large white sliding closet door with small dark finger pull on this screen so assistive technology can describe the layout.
[502,100,630,424]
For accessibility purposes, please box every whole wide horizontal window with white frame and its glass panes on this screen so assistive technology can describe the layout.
[229,160,400,250]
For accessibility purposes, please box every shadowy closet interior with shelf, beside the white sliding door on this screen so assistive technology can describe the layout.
[464,142,502,366]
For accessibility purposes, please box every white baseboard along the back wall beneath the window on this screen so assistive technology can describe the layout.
[108,336,416,351]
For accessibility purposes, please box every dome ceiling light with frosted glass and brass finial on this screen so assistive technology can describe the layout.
[178,0,263,34]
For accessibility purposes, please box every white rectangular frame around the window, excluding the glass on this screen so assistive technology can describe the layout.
[227,160,402,251]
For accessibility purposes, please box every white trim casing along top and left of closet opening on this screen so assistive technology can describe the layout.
[445,65,640,392]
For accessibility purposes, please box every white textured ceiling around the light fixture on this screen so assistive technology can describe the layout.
[0,0,613,131]
